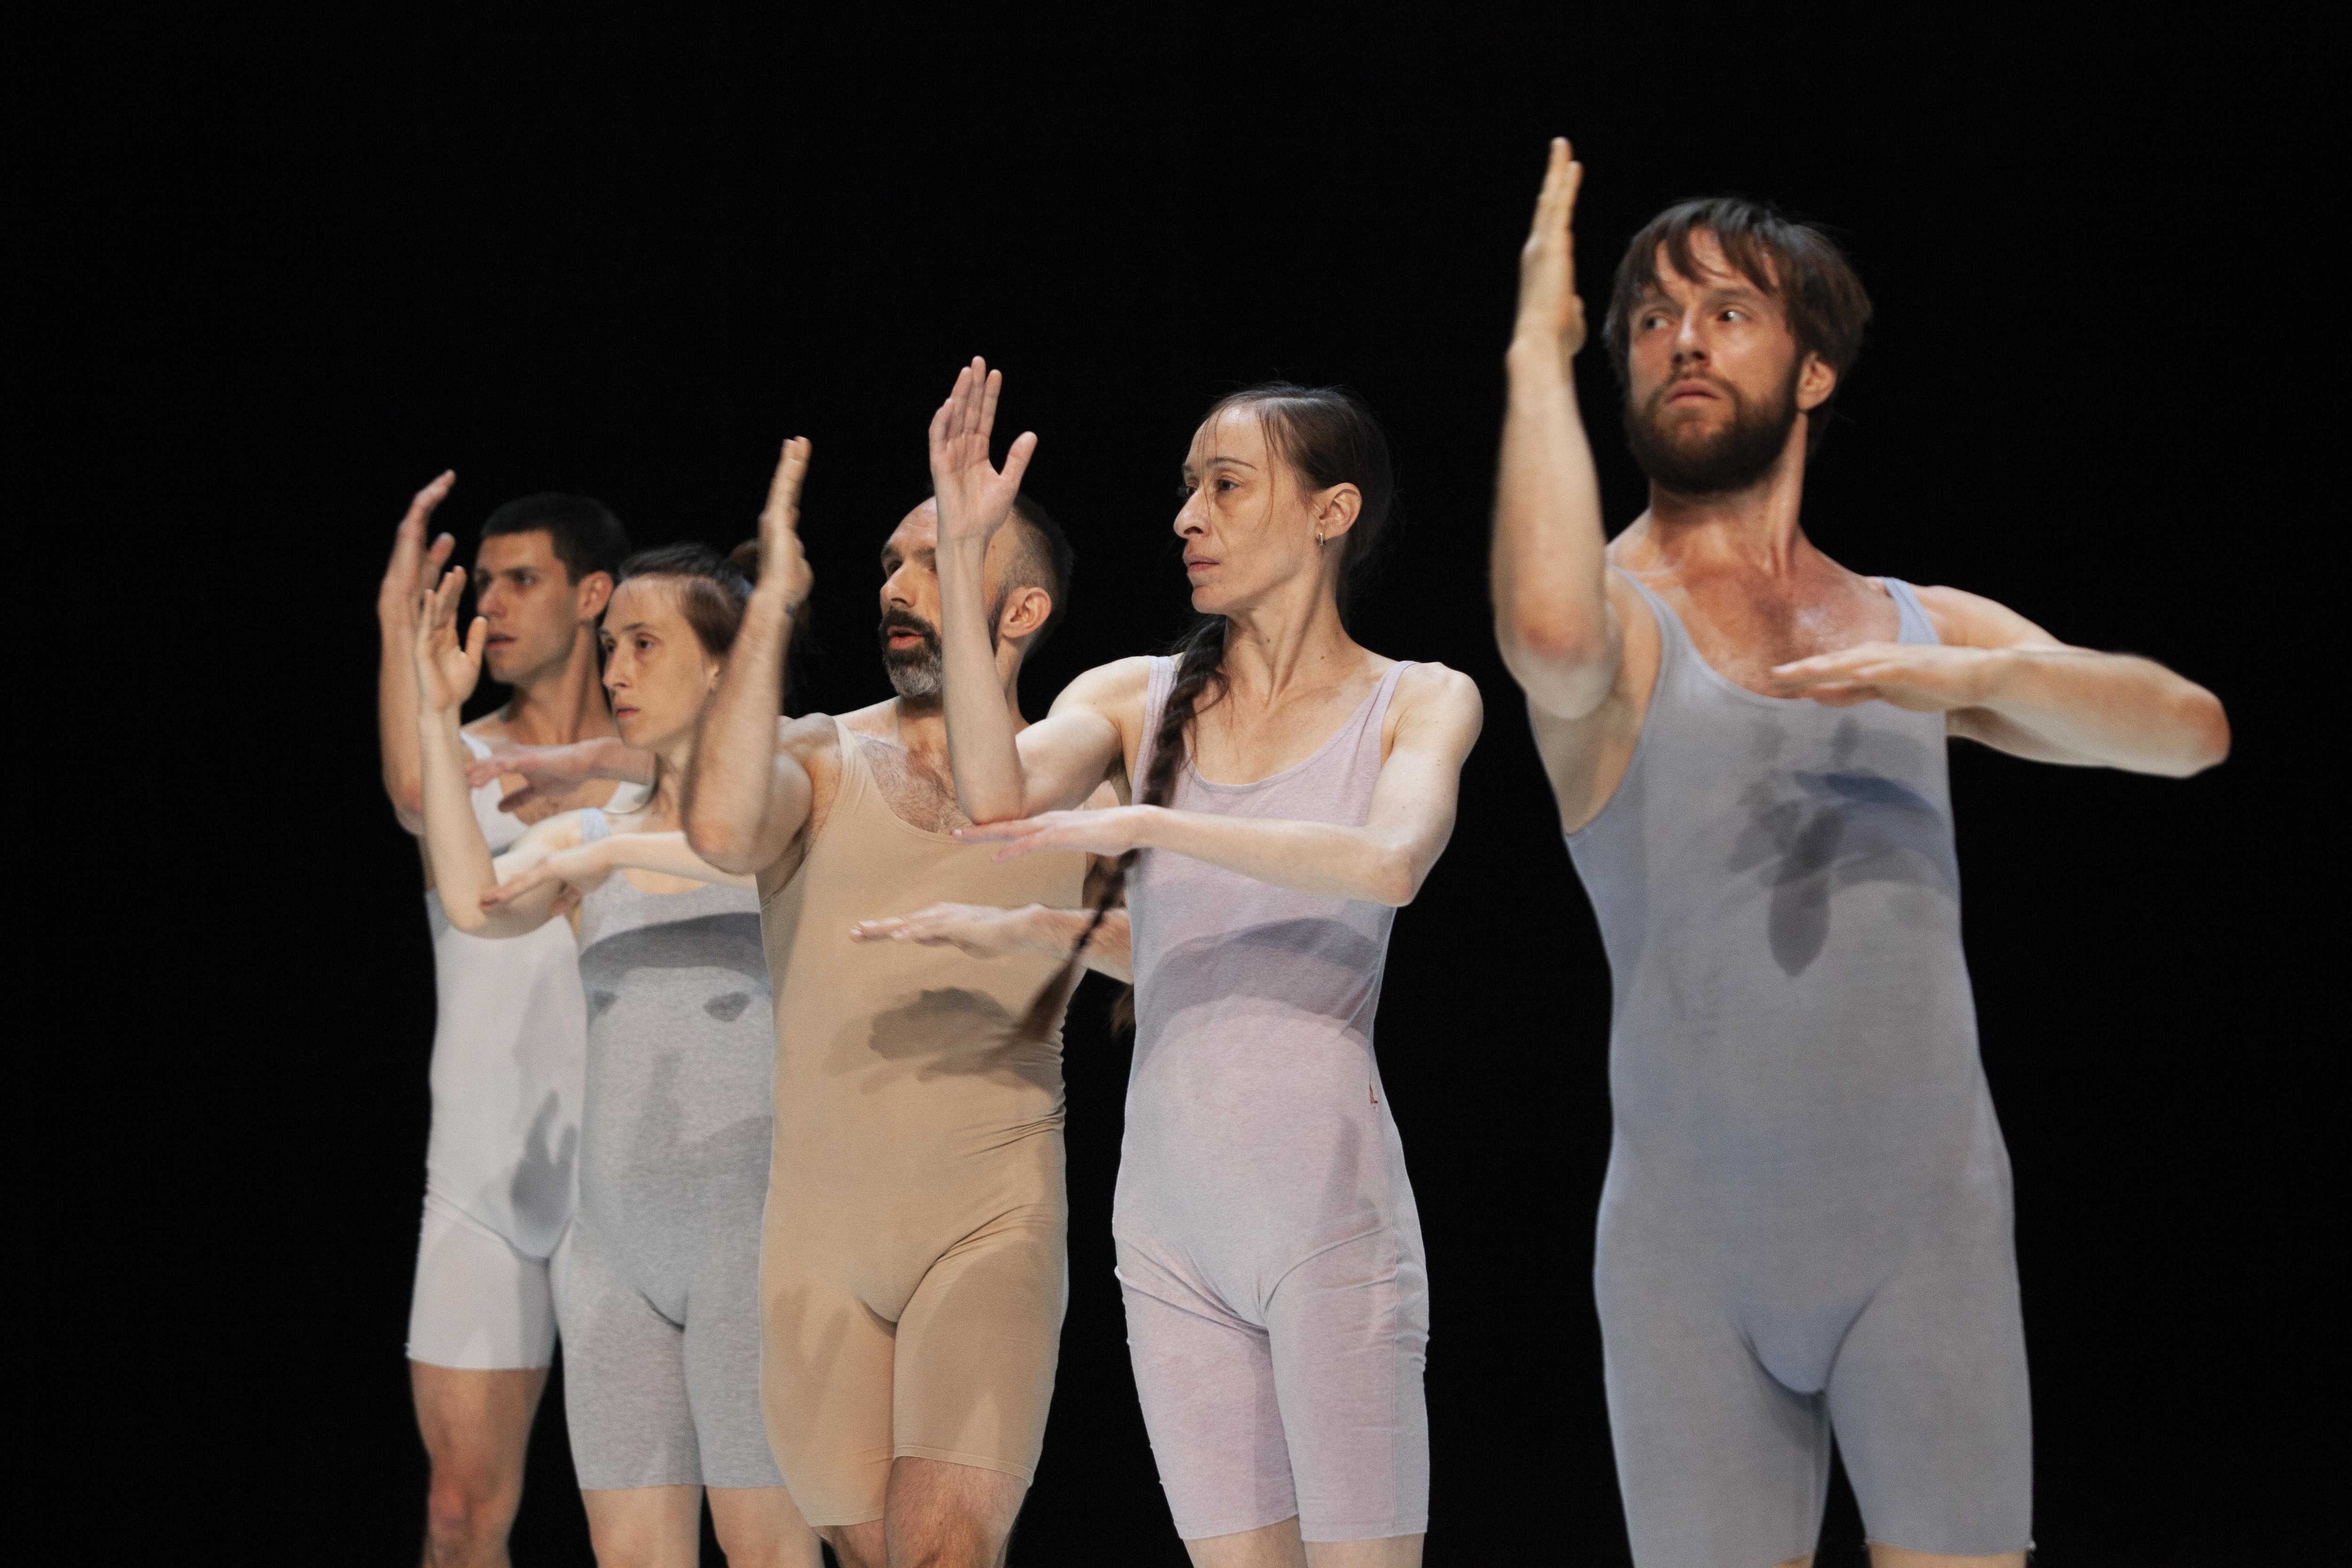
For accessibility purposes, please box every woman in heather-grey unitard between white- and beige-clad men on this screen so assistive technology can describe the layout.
[416,517,818,1568]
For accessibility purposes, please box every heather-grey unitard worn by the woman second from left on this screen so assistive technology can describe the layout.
[564,811,783,1490]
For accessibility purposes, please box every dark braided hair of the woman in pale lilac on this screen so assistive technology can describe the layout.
[1021,381,1397,1039]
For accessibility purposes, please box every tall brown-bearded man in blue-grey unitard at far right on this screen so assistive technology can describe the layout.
[1494,141,2230,1568]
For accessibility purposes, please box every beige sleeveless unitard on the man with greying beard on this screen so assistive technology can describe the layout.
[760,724,1084,1526]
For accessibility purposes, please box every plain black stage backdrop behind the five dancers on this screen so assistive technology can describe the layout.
[37,7,2343,1568]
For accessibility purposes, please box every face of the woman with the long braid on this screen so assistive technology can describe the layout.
[1176,406,1352,616]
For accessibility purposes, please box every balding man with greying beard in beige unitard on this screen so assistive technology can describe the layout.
[684,442,1087,1568]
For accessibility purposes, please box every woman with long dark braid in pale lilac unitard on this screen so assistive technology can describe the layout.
[931,365,1479,1566]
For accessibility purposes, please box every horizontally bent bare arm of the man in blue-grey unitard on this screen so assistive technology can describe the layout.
[1773,588,2230,778]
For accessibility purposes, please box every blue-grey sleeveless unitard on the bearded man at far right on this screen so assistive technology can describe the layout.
[1569,578,2032,1568]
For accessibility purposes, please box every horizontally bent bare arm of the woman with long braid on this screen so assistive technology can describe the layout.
[955,665,1484,905]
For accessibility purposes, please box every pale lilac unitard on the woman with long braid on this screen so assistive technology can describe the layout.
[1112,658,1430,1540]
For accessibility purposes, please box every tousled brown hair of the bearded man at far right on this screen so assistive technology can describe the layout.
[1602,195,1870,451]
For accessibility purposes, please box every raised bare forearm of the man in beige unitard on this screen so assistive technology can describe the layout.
[680,437,814,877]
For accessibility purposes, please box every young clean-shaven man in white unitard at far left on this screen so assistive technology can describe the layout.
[376,472,635,1568]
